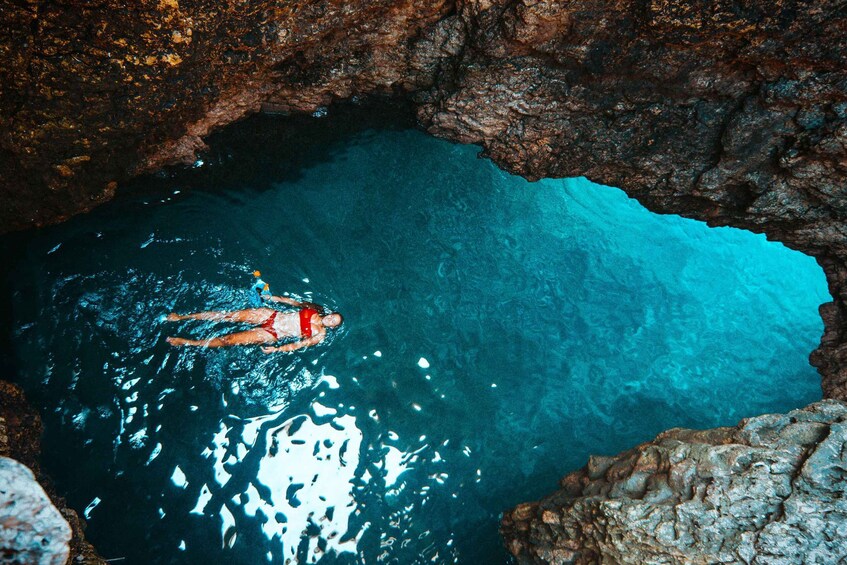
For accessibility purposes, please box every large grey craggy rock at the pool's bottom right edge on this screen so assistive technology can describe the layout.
[502,400,847,565]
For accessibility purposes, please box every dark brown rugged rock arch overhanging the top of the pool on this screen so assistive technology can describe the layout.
[0,0,847,562]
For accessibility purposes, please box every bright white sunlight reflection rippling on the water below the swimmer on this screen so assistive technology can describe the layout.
[177,369,452,562]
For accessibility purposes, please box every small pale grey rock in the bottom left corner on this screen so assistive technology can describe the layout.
[0,457,71,565]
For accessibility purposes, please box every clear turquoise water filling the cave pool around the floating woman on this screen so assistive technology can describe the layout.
[6,108,829,563]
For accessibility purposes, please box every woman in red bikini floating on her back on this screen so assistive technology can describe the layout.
[165,296,344,353]
